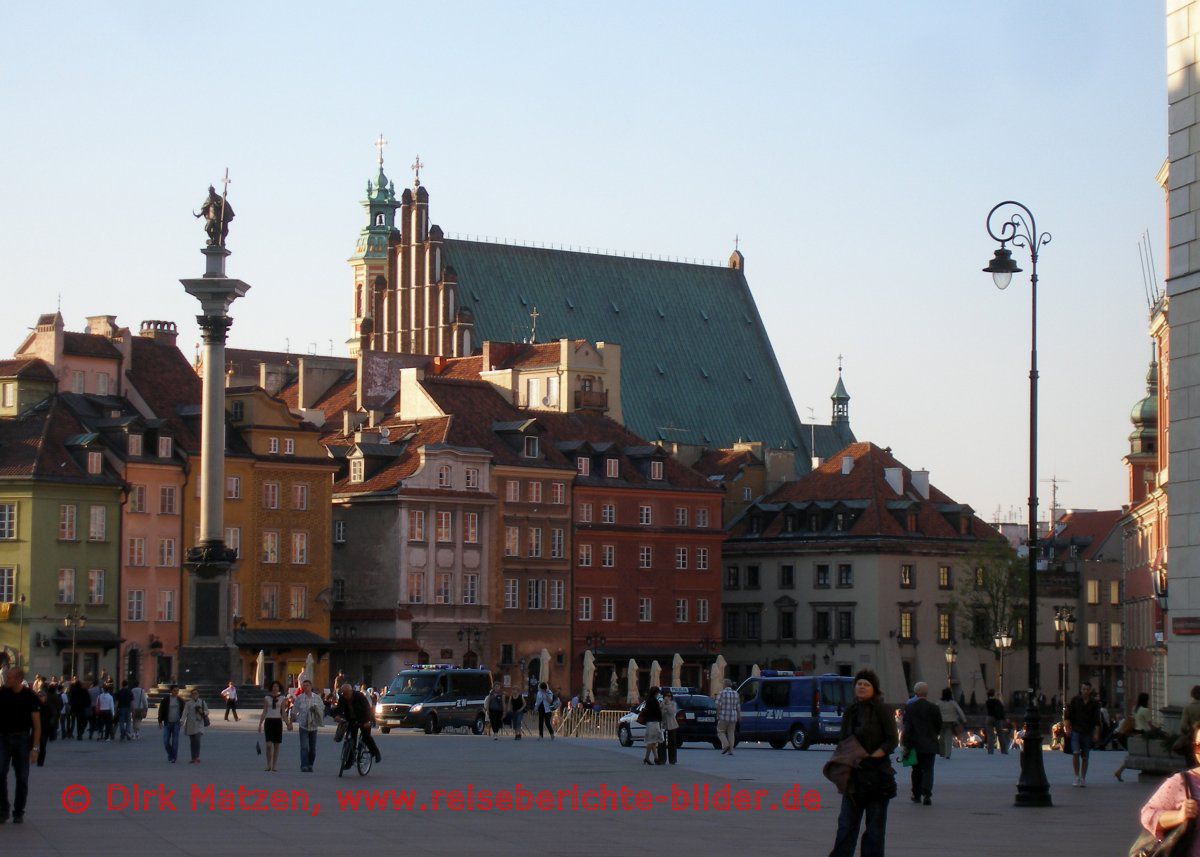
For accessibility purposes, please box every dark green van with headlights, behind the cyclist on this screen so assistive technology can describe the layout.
[376,664,492,735]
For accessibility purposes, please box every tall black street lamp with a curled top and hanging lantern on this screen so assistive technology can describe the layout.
[983,199,1050,807]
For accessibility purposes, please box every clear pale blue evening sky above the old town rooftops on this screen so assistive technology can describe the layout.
[0,0,1166,520]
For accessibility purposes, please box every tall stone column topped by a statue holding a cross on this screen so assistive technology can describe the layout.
[179,176,250,687]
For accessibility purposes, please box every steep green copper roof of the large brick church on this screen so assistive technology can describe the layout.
[444,239,853,460]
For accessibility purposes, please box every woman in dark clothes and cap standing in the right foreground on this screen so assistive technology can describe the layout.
[829,670,897,857]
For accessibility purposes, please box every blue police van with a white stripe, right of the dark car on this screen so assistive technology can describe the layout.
[738,670,854,750]
